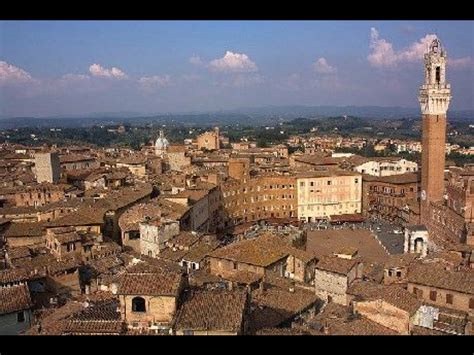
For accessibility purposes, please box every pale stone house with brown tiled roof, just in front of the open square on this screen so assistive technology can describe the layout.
[314,256,363,305]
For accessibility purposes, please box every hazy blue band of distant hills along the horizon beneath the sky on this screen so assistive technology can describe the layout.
[0,105,474,129]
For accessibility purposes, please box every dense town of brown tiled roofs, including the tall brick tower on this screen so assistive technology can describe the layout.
[0,39,474,336]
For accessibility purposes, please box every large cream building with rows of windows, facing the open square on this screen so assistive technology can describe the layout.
[296,170,362,222]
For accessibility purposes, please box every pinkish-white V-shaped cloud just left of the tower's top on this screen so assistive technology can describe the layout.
[367,27,436,67]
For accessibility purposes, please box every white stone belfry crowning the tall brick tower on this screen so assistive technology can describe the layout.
[418,38,451,115]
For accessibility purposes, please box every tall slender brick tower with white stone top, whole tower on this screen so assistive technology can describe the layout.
[418,39,451,223]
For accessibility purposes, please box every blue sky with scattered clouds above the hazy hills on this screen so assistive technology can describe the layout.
[0,21,474,117]
